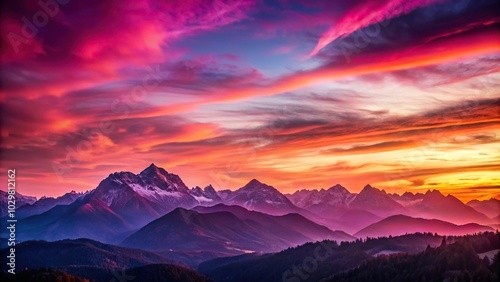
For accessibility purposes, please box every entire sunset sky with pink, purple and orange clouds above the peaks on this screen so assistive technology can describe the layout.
[0,0,500,201]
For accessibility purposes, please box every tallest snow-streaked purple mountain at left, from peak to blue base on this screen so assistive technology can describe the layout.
[13,164,208,243]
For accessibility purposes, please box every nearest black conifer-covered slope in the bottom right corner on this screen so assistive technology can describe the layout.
[330,232,500,282]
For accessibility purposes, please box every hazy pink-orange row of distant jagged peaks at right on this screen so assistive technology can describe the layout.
[287,184,500,233]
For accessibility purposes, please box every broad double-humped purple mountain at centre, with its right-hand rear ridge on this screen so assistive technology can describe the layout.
[121,207,352,254]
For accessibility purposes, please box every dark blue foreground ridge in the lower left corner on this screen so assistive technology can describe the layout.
[0,239,210,282]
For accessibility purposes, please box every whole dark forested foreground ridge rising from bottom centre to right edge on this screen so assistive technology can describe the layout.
[198,232,500,282]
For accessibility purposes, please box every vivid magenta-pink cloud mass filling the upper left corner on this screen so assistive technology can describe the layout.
[0,0,253,100]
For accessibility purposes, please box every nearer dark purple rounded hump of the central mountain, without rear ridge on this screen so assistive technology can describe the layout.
[121,208,278,251]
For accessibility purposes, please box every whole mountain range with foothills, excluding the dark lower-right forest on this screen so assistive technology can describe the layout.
[0,164,500,281]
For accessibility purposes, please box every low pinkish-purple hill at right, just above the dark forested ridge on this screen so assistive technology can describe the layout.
[354,215,493,238]
